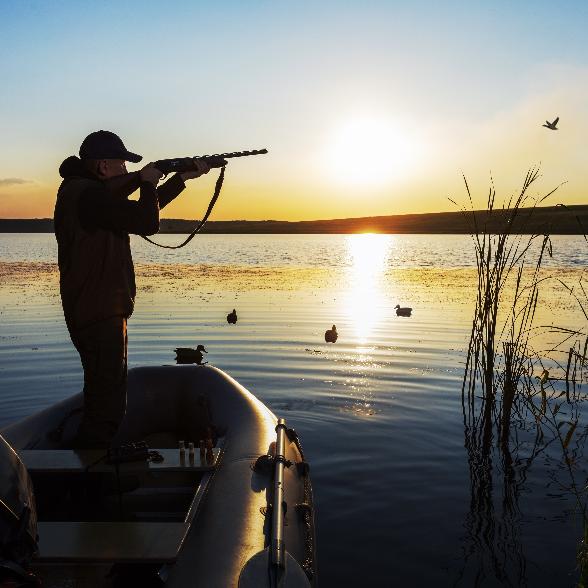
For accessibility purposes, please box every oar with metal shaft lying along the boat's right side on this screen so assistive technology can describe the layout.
[239,419,310,588]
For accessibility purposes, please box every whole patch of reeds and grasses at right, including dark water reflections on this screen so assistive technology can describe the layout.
[454,168,588,585]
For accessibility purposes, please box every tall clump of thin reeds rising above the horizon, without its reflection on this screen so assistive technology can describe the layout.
[452,168,557,432]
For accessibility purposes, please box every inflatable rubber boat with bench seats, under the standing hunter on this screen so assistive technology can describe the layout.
[0,365,317,588]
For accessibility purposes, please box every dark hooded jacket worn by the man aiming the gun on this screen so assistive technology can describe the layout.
[54,157,185,331]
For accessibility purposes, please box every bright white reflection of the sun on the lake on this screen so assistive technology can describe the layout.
[344,233,392,344]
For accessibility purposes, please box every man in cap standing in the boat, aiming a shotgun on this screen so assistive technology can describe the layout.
[54,131,210,448]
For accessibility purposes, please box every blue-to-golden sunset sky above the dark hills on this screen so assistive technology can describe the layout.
[0,0,588,220]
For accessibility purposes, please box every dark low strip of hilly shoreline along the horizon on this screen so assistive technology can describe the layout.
[0,205,588,235]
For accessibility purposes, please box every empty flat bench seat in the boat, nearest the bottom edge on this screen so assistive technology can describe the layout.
[35,521,190,563]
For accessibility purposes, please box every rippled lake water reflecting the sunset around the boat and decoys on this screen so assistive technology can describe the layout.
[0,234,588,588]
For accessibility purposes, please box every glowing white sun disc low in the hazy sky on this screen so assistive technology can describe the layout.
[326,117,416,186]
